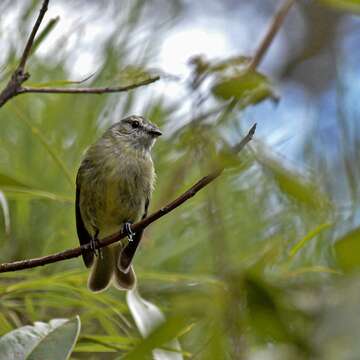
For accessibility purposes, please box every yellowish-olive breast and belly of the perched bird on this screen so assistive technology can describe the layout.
[80,154,154,239]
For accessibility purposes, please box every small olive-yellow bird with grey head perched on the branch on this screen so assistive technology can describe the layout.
[76,115,161,291]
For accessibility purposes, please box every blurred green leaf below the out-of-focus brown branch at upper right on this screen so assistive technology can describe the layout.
[212,71,274,105]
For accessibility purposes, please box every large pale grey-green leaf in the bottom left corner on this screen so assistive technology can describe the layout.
[0,316,80,360]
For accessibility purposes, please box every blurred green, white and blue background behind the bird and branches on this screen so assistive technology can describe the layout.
[0,0,360,360]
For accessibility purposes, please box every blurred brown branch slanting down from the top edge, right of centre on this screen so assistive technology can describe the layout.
[249,0,296,70]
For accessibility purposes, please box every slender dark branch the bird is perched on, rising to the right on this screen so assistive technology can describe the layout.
[0,124,256,273]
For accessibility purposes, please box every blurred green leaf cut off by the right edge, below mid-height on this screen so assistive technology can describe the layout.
[335,228,360,271]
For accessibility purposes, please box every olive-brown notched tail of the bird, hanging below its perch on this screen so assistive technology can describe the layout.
[88,244,136,292]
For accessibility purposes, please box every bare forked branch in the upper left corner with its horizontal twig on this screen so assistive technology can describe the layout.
[0,0,160,107]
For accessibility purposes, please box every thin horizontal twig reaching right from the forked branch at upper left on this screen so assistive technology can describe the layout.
[19,76,160,94]
